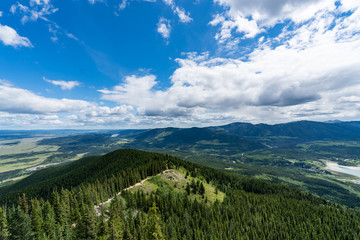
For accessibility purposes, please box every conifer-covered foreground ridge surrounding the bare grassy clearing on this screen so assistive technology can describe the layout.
[0,149,360,240]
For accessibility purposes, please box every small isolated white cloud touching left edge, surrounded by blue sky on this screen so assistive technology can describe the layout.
[0,24,32,47]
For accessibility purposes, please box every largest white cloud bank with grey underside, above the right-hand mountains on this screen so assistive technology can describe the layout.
[100,5,360,122]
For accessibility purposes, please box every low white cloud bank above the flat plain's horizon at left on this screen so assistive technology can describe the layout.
[0,80,136,128]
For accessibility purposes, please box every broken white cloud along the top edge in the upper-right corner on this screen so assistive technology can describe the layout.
[210,0,360,46]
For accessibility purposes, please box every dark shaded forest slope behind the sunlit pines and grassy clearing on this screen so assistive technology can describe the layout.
[0,149,165,202]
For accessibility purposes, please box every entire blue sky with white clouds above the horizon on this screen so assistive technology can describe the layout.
[0,0,360,130]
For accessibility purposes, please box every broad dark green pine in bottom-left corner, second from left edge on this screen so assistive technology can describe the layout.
[9,206,33,240]
